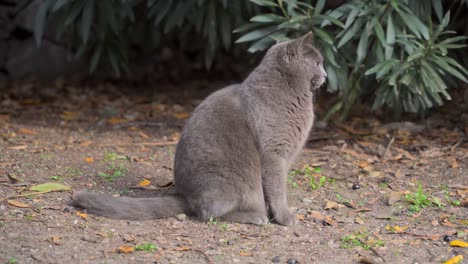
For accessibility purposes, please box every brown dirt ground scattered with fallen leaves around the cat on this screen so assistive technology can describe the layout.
[0,80,468,264]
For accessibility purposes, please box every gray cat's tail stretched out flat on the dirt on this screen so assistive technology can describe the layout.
[70,191,186,220]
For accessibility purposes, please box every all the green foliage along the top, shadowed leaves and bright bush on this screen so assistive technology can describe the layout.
[18,0,468,116]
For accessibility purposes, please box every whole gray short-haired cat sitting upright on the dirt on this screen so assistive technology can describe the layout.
[72,33,327,225]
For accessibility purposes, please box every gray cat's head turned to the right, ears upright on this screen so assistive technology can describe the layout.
[271,32,327,90]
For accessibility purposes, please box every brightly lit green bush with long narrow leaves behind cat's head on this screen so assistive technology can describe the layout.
[236,0,468,119]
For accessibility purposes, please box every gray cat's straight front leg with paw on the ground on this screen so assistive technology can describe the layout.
[262,154,298,225]
